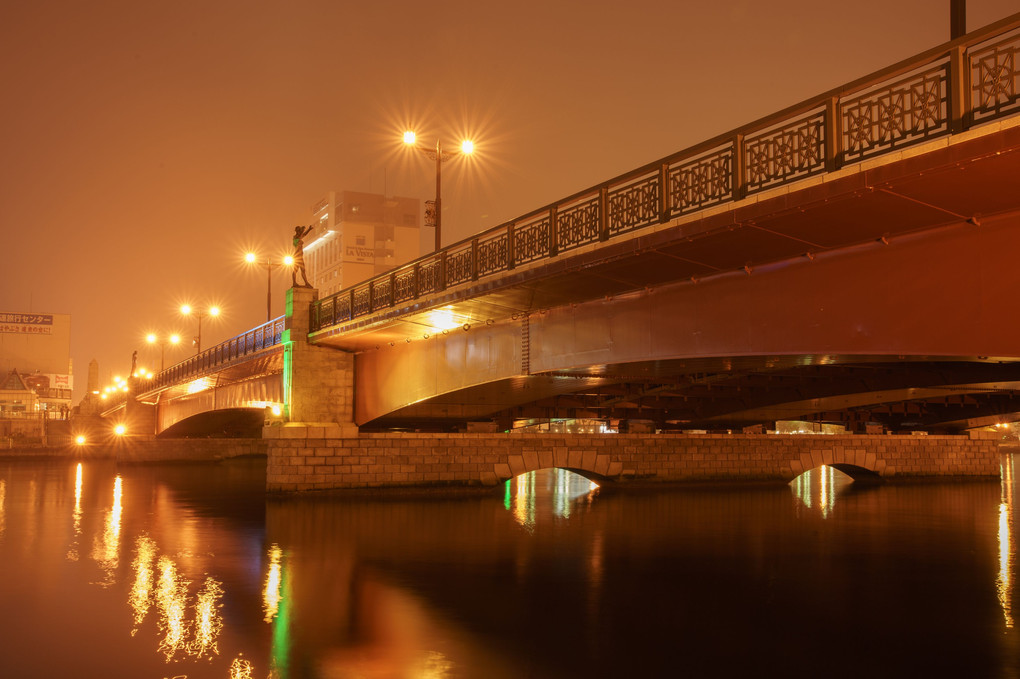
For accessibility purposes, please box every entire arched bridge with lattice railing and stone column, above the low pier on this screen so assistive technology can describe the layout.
[105,14,1020,487]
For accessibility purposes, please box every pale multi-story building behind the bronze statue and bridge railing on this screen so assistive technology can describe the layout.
[304,191,421,297]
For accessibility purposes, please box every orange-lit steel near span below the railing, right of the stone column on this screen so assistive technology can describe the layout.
[313,127,1020,430]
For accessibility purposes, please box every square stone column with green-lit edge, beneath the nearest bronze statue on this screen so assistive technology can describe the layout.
[279,288,358,438]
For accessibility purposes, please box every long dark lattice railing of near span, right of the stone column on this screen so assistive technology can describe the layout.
[311,14,1020,331]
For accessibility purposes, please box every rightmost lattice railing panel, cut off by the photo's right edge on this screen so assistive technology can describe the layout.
[969,28,1020,122]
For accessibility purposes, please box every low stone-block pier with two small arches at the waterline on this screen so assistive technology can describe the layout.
[263,426,1000,492]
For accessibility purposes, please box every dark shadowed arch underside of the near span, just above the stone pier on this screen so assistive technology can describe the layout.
[362,356,1020,432]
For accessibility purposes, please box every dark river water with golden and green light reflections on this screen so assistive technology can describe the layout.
[0,457,1020,679]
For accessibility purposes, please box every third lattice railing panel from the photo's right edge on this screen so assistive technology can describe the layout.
[744,111,825,194]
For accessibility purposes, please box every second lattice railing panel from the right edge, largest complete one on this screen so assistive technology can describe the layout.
[839,63,949,162]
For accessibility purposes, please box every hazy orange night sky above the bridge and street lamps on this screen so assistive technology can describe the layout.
[0,0,1020,403]
